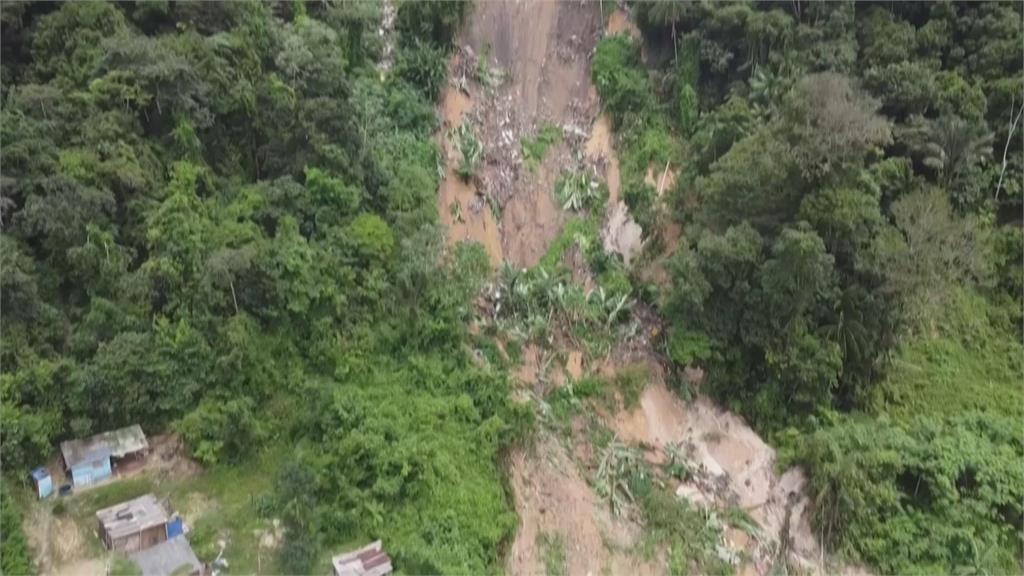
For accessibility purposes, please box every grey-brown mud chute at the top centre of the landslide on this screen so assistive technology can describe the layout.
[463,1,602,266]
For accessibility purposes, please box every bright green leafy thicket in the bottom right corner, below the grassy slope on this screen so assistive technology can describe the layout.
[798,412,1024,574]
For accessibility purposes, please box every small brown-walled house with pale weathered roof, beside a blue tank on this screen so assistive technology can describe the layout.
[96,494,169,552]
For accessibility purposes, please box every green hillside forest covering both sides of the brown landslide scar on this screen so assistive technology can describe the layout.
[0,0,1024,574]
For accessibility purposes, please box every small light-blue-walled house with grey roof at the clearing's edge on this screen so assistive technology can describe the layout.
[60,424,150,487]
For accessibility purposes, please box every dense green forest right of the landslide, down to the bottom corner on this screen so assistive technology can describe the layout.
[593,2,1024,574]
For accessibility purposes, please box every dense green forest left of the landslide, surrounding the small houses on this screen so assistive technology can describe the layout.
[0,2,529,573]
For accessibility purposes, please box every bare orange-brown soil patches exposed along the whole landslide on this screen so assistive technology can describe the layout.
[438,0,820,575]
